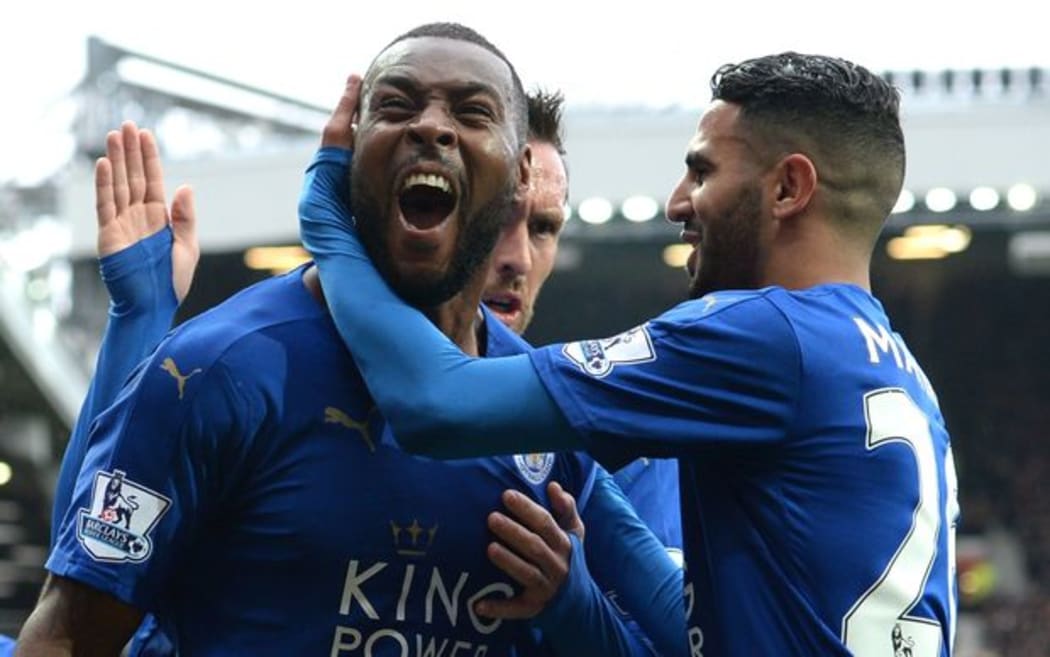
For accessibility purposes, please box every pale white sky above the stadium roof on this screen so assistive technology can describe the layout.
[0,0,1050,184]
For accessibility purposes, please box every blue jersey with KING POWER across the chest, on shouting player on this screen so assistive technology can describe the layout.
[47,267,594,657]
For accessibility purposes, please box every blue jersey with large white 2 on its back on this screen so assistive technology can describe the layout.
[532,284,958,657]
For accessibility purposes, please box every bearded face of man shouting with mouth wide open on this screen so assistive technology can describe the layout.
[351,37,526,306]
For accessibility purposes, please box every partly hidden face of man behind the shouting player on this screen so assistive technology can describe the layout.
[482,141,569,334]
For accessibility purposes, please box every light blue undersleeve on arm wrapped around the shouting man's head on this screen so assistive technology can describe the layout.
[299,148,578,458]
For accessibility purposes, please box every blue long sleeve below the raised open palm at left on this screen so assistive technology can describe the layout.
[51,228,179,545]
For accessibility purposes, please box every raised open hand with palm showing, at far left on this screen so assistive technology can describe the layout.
[95,121,201,301]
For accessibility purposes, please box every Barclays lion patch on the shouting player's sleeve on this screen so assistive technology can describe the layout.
[77,470,171,563]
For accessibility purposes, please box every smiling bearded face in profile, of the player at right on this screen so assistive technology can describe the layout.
[667,101,770,299]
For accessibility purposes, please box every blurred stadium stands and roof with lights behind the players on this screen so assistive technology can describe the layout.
[0,39,1050,657]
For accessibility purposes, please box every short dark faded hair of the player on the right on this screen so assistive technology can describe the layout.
[711,52,905,234]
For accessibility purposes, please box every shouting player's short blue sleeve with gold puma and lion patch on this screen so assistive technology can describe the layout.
[46,341,265,611]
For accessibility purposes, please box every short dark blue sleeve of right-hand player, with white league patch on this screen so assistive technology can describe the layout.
[530,292,801,470]
